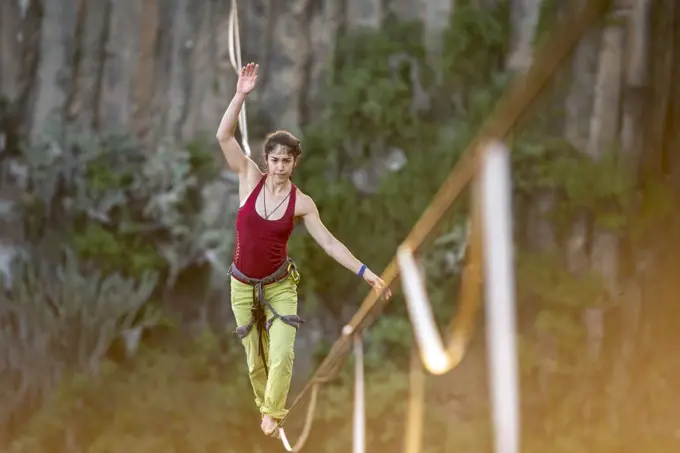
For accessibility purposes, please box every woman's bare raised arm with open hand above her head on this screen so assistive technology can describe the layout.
[216,63,259,176]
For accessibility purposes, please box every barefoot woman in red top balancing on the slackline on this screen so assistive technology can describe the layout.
[217,63,391,436]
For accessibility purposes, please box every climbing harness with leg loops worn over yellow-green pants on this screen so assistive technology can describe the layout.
[228,257,305,375]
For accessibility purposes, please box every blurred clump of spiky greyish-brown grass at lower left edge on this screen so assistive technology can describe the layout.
[0,253,158,434]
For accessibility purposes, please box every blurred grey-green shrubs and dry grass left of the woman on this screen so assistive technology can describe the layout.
[0,122,231,444]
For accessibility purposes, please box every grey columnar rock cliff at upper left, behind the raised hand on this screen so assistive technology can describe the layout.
[0,0,453,142]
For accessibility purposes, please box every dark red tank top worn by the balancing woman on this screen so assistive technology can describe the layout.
[234,175,297,278]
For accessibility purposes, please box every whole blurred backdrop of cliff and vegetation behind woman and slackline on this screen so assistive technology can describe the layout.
[0,0,680,453]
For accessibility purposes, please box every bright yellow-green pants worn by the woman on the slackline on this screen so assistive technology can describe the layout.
[231,276,298,419]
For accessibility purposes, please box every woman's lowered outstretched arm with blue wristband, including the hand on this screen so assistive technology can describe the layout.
[299,195,391,297]
